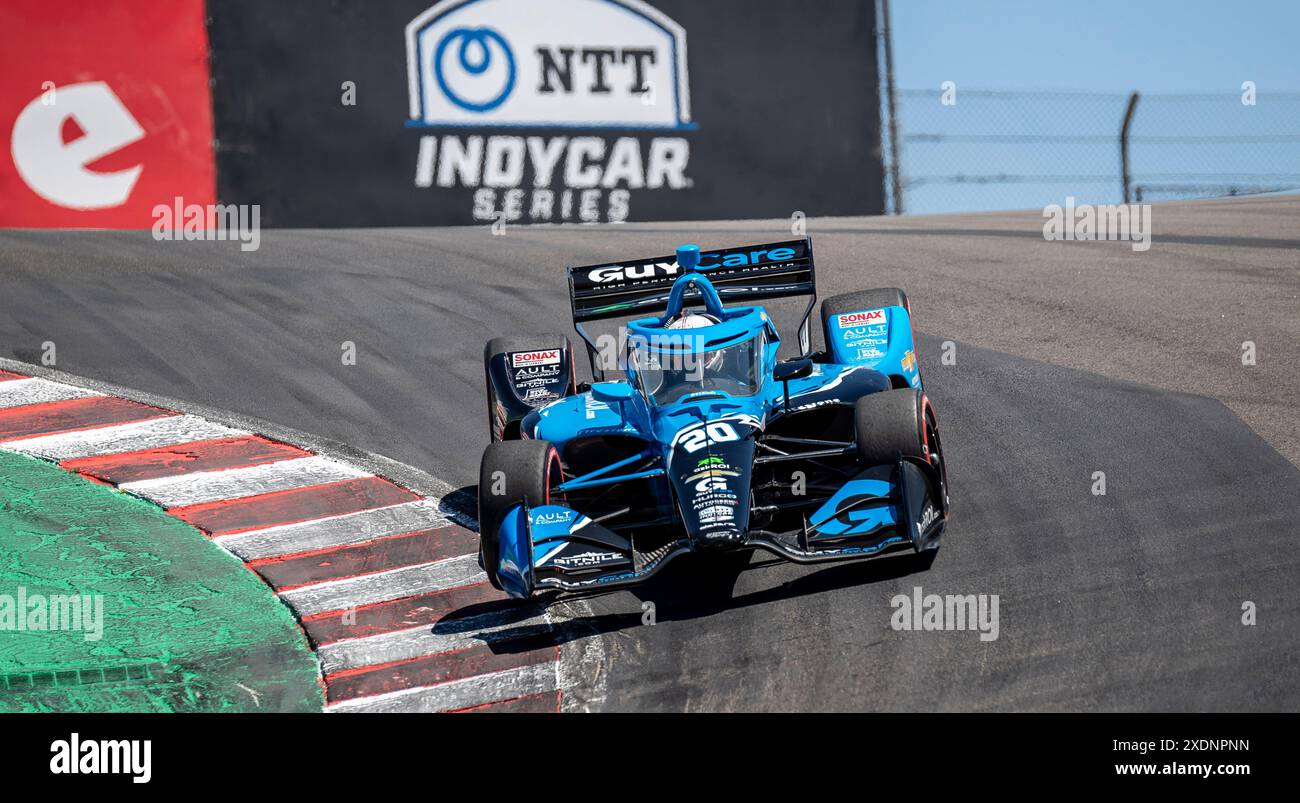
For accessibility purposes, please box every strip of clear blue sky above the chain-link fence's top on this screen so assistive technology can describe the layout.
[891,0,1300,92]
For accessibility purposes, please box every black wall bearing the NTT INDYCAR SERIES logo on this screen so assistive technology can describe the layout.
[209,0,884,226]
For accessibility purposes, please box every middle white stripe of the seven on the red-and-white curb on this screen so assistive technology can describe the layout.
[216,499,451,560]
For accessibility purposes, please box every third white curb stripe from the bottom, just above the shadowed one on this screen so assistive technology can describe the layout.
[280,555,488,616]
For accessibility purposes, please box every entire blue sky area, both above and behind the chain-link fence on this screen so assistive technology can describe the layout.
[891,0,1300,213]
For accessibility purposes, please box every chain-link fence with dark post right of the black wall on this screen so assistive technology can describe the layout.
[884,86,1300,213]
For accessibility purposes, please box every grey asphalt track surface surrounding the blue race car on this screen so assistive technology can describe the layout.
[0,198,1300,711]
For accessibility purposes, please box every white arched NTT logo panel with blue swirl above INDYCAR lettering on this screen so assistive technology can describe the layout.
[406,0,694,129]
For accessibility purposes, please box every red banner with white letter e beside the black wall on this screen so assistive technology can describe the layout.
[0,0,216,229]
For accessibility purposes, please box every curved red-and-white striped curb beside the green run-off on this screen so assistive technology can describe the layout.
[0,370,566,712]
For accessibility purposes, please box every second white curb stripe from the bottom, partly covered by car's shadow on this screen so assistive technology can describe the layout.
[316,607,555,674]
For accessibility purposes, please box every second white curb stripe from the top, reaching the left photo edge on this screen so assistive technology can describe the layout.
[0,416,248,460]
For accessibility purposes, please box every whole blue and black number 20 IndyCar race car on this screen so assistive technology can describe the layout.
[478,233,949,598]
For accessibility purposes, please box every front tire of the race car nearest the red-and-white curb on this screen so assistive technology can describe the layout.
[478,440,564,589]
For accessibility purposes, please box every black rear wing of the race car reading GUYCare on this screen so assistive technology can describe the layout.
[567,238,816,379]
